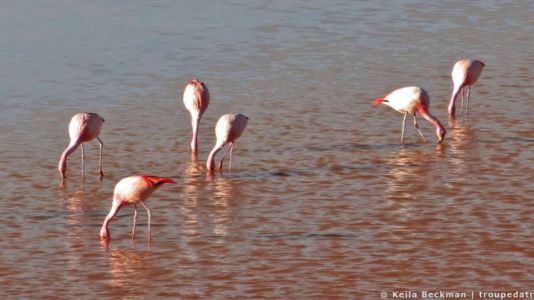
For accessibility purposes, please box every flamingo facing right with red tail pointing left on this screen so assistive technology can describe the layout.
[373,86,446,143]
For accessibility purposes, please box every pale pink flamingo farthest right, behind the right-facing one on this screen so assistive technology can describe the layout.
[449,59,486,117]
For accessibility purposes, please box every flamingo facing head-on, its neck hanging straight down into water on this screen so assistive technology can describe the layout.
[183,78,210,158]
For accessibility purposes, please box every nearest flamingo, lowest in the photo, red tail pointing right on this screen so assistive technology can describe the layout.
[100,175,176,241]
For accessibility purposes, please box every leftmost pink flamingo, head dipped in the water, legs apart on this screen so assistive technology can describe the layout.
[58,113,104,178]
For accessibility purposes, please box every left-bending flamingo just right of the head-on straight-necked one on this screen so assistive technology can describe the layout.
[206,113,248,173]
